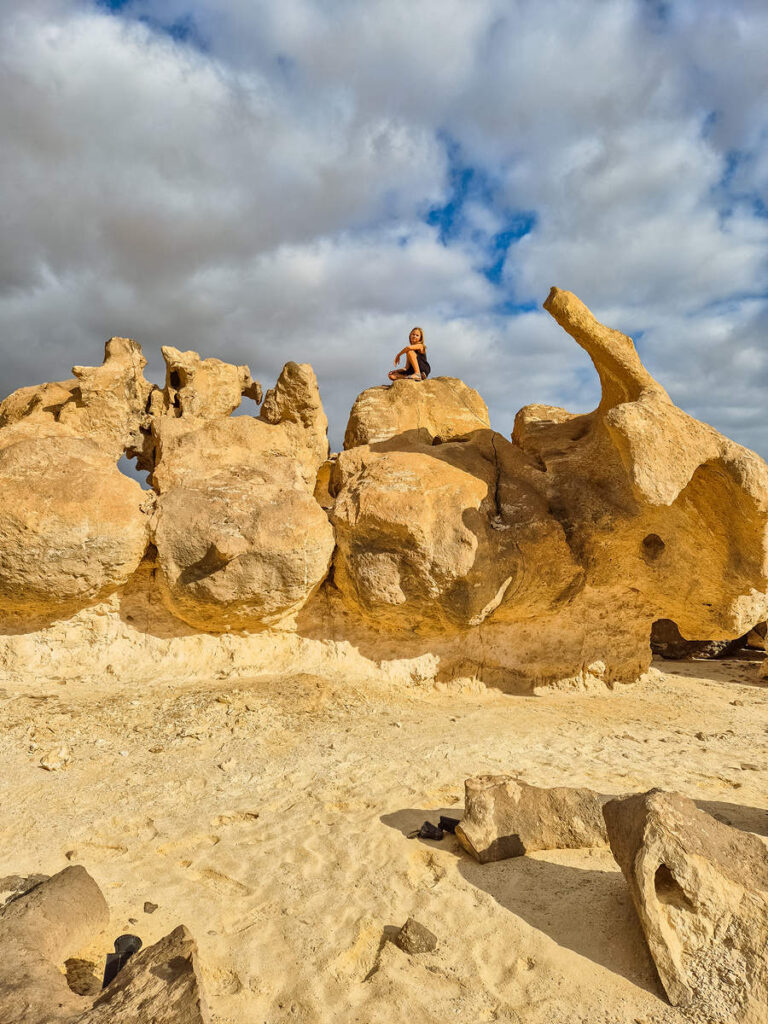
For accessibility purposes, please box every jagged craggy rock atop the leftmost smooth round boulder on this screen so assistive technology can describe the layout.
[0,338,156,461]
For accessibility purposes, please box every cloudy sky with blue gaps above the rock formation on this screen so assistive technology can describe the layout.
[0,0,768,456]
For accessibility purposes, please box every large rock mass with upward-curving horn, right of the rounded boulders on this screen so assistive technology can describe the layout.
[331,289,768,679]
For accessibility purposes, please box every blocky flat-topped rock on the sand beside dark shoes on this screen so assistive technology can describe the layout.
[456,775,608,864]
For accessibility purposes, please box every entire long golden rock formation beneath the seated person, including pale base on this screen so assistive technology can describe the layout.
[0,289,768,689]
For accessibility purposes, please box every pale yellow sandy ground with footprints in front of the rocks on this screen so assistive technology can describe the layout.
[0,660,768,1024]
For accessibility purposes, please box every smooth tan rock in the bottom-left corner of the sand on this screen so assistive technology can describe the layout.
[0,866,110,1024]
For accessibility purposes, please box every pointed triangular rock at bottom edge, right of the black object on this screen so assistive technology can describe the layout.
[77,925,211,1024]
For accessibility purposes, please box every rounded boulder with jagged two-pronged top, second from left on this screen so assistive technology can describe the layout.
[153,349,334,632]
